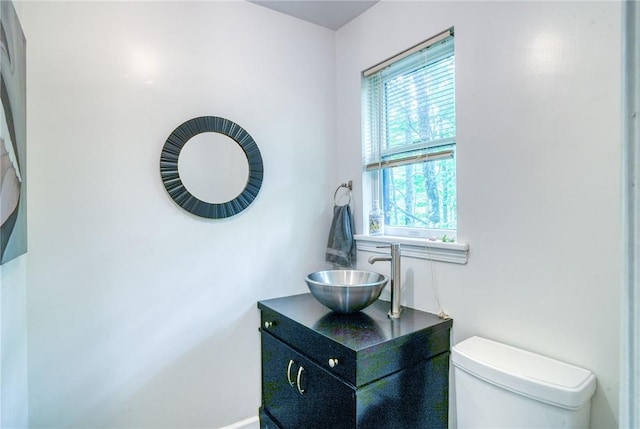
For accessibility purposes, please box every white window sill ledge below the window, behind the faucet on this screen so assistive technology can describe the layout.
[354,235,469,264]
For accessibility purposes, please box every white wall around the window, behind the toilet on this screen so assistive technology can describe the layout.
[336,1,622,429]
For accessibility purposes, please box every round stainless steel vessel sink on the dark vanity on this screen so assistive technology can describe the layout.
[305,270,389,313]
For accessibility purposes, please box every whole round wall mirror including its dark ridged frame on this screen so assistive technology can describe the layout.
[160,116,263,219]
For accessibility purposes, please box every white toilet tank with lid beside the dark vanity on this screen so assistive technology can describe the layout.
[451,337,596,429]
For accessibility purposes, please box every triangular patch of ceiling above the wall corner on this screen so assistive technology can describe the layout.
[249,0,379,30]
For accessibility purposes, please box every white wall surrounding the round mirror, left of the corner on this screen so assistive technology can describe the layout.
[21,1,337,428]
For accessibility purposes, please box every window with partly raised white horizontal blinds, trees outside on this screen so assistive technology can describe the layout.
[362,29,457,240]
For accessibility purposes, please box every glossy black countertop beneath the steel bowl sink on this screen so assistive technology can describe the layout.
[258,293,453,352]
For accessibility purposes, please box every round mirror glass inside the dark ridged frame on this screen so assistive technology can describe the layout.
[178,132,249,204]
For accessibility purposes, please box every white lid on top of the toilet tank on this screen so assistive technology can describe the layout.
[451,337,596,409]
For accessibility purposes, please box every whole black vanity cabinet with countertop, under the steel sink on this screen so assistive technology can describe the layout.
[258,294,453,429]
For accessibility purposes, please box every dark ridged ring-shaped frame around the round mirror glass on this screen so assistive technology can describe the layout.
[160,116,264,219]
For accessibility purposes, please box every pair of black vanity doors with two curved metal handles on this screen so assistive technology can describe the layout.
[262,332,356,429]
